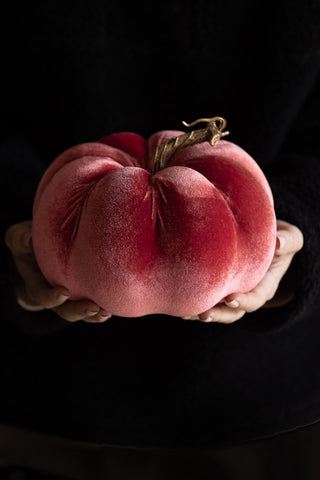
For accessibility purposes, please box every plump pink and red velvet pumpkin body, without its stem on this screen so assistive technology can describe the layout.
[32,117,276,317]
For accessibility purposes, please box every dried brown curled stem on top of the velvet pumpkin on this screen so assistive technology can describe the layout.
[151,117,229,174]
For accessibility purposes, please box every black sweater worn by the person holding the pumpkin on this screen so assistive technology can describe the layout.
[0,0,320,446]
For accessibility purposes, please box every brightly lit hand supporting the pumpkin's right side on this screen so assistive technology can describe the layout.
[183,220,303,323]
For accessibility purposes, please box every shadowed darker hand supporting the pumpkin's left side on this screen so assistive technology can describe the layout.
[5,221,111,323]
